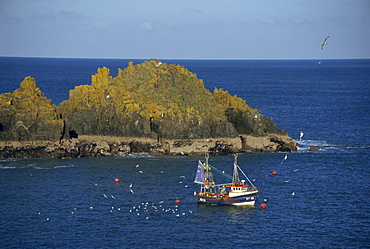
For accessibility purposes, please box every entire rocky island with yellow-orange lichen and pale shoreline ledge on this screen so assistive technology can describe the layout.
[0,60,297,158]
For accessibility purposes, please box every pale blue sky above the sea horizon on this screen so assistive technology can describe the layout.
[0,0,370,59]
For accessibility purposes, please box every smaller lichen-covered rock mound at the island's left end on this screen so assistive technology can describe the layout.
[0,77,65,141]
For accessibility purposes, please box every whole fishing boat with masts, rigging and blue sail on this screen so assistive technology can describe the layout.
[194,155,258,205]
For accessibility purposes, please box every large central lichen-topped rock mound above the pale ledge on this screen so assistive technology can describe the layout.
[58,60,286,139]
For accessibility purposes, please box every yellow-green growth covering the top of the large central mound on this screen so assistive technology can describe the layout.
[60,60,260,122]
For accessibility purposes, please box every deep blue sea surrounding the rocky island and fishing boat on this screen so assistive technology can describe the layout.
[0,57,370,248]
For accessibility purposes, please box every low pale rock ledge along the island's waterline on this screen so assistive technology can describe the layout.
[0,135,295,158]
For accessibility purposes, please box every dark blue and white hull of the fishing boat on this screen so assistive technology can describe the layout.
[196,191,258,206]
